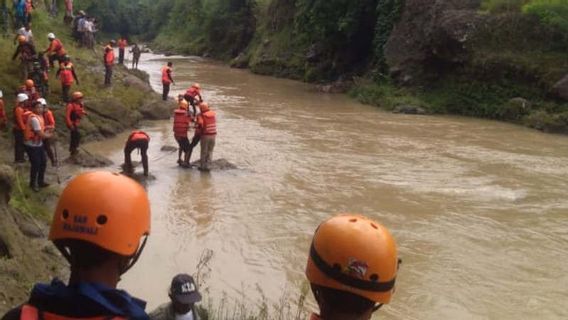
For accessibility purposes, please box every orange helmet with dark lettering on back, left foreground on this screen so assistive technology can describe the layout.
[49,171,150,256]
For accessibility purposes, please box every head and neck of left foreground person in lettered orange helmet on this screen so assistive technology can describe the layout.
[49,171,150,287]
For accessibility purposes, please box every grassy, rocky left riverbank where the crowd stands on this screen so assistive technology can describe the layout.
[0,7,171,314]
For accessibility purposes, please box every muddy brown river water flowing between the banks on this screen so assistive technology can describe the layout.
[89,54,568,319]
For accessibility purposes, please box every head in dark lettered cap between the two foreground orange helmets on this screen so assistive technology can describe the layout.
[168,273,201,315]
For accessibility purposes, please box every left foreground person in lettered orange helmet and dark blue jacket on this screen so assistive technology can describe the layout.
[2,171,150,320]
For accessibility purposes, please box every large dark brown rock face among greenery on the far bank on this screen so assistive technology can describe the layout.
[384,0,483,84]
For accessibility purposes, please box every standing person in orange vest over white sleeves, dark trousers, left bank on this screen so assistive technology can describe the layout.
[24,101,51,192]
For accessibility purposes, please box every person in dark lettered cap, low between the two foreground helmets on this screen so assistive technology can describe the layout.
[150,273,201,320]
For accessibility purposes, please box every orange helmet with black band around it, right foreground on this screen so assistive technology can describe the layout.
[306,214,399,303]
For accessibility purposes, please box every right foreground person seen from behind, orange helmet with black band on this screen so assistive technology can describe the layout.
[306,214,400,320]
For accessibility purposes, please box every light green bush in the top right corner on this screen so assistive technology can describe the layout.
[523,0,568,32]
